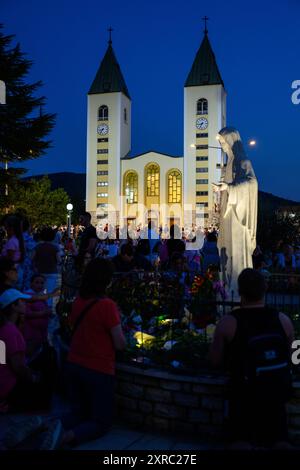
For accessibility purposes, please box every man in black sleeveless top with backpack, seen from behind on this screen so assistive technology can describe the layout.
[210,268,294,449]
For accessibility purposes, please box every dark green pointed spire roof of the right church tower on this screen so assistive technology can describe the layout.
[184,31,224,87]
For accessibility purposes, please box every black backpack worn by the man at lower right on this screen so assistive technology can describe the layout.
[234,310,292,401]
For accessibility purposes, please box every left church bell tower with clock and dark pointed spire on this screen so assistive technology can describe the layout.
[86,27,131,225]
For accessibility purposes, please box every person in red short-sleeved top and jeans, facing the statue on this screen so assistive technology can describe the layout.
[62,258,125,444]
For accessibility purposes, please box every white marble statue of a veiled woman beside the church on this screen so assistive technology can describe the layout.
[213,127,258,300]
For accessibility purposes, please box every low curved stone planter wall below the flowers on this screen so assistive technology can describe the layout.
[116,364,300,443]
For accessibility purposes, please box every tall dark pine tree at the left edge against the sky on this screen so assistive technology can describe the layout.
[0,25,55,210]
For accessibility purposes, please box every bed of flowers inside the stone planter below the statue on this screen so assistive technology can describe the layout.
[61,272,222,373]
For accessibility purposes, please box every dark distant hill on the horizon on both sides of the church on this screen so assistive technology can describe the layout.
[26,172,300,218]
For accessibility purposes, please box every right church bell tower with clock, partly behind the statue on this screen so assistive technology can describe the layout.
[183,27,226,226]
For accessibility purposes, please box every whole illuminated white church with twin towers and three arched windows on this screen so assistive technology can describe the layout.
[86,30,226,226]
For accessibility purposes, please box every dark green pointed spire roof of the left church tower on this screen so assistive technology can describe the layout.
[88,41,130,99]
